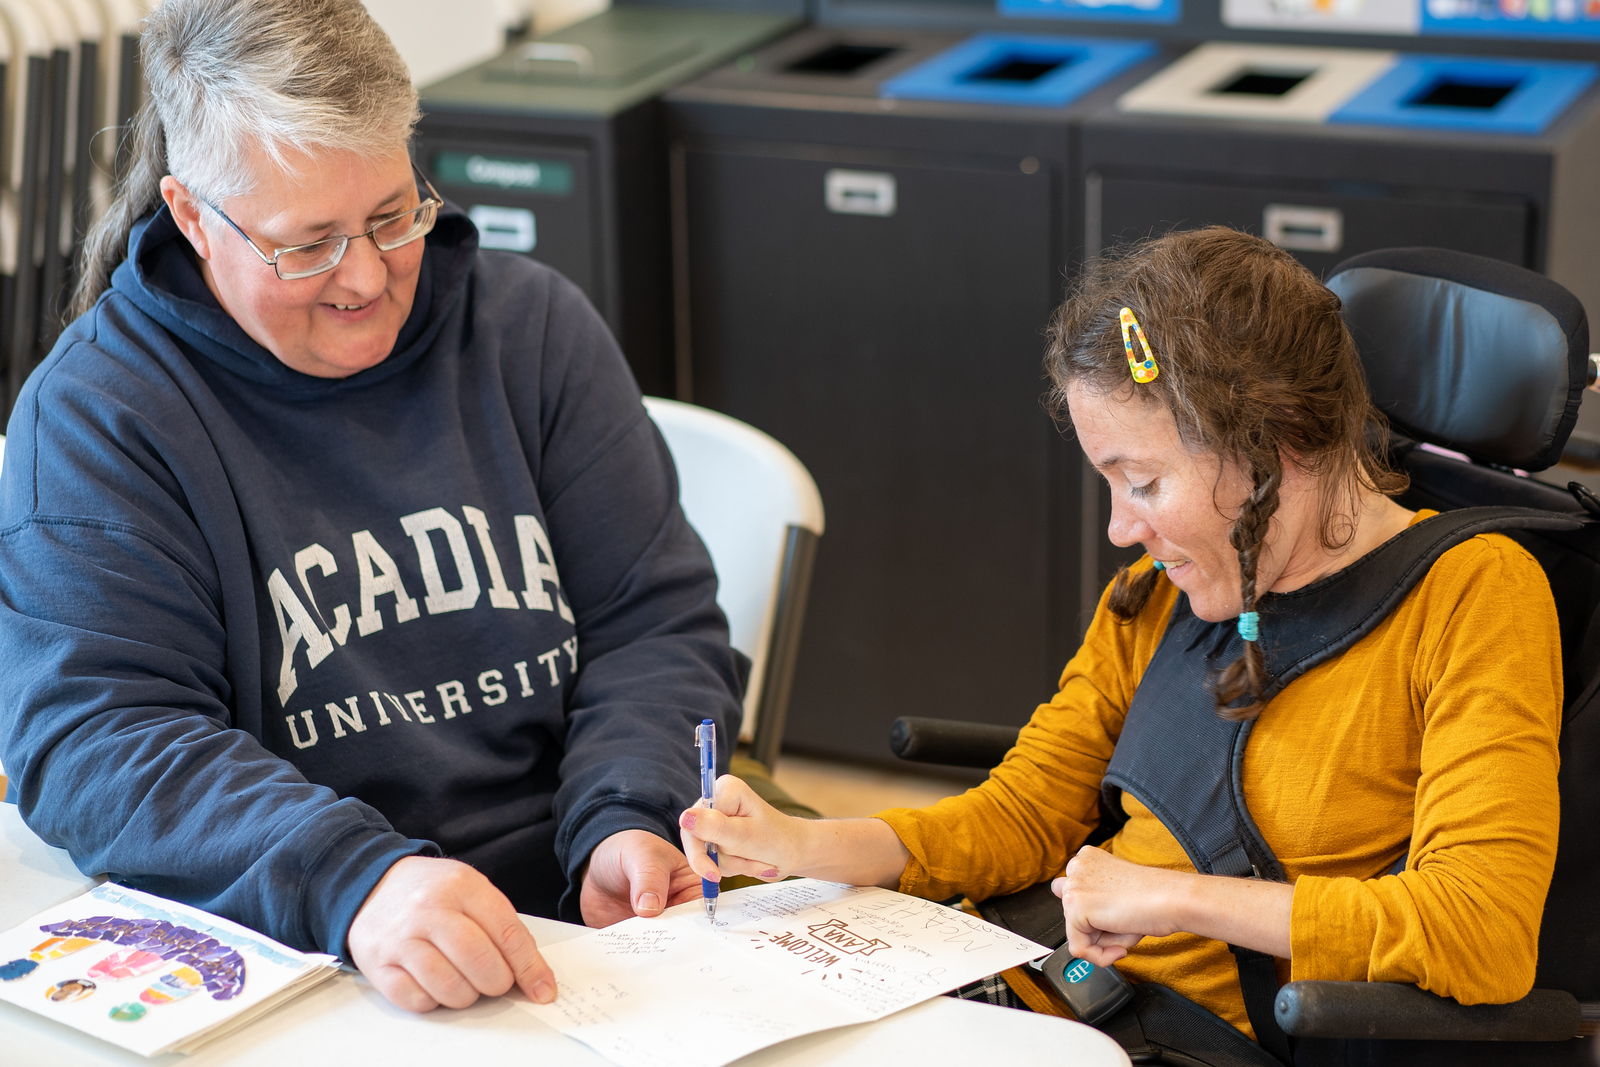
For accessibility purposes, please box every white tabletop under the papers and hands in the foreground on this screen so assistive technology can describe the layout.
[0,803,1128,1067]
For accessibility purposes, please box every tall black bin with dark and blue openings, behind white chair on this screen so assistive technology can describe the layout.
[666,29,1155,763]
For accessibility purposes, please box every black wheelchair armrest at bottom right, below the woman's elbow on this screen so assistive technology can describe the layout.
[1272,982,1587,1041]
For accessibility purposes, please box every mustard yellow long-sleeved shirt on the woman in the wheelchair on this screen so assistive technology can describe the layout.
[878,512,1562,1033]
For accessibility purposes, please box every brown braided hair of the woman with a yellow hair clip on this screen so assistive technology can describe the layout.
[1045,226,1406,720]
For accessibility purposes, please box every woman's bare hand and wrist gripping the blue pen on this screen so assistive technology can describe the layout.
[678,774,910,888]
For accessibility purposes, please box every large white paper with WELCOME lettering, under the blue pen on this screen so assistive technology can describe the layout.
[518,880,1048,1067]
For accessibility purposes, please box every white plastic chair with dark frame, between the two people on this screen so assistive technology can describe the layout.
[645,397,822,769]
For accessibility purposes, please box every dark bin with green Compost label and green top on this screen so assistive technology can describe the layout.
[416,6,797,395]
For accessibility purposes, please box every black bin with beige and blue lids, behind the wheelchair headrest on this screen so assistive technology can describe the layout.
[1080,45,1600,432]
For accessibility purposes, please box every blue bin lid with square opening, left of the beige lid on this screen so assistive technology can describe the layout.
[878,34,1155,107]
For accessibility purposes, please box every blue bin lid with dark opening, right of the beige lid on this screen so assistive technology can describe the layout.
[1328,56,1600,134]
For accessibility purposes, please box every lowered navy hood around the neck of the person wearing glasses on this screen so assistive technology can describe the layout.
[110,203,478,397]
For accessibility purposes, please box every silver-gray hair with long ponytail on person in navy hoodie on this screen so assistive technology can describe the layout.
[72,0,418,315]
